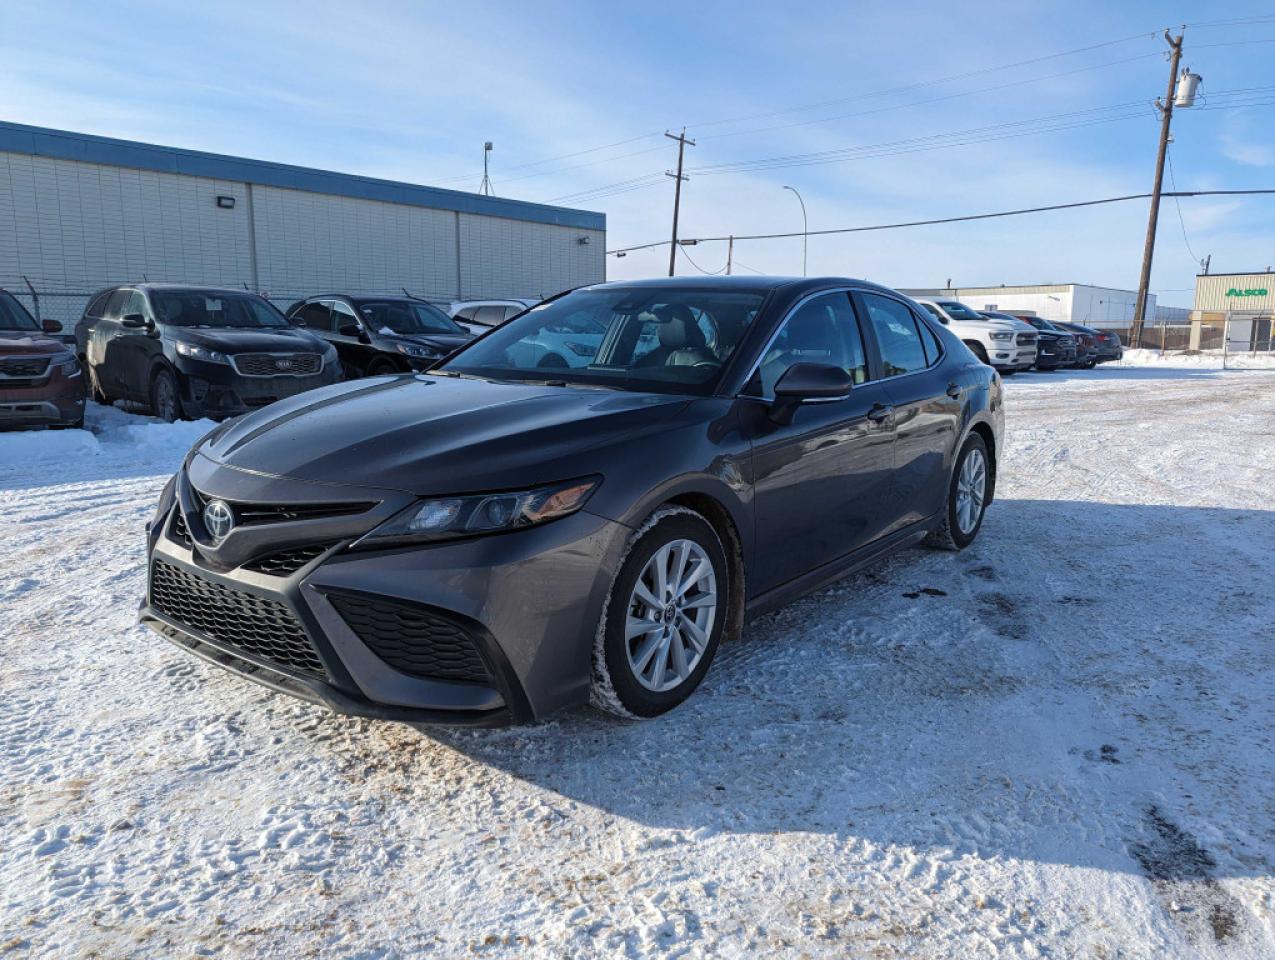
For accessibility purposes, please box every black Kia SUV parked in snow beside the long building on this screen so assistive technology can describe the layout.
[75,283,340,421]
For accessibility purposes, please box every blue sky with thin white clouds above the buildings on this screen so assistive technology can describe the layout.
[0,0,1275,305]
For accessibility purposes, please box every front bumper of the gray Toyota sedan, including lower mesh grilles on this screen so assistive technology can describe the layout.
[139,478,630,725]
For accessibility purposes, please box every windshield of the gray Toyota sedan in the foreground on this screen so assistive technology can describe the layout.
[440,287,764,395]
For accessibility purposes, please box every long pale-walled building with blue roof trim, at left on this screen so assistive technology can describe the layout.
[0,122,606,321]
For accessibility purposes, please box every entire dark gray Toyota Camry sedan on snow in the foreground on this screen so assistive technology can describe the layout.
[142,277,1003,724]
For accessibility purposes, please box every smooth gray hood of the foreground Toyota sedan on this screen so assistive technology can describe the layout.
[199,375,689,495]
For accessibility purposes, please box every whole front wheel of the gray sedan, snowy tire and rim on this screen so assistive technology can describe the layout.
[589,507,731,719]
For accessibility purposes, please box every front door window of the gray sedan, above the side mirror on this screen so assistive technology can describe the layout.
[748,293,868,400]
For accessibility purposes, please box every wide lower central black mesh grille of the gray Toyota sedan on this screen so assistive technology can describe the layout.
[150,560,325,680]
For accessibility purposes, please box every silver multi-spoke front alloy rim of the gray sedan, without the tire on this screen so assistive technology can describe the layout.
[625,539,718,694]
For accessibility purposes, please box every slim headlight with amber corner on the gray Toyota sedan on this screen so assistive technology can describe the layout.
[353,477,602,547]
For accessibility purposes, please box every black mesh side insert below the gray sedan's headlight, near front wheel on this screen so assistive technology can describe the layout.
[328,593,491,683]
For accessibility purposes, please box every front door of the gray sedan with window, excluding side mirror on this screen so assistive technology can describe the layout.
[741,291,894,593]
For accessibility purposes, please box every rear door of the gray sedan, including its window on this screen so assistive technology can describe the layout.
[854,291,965,534]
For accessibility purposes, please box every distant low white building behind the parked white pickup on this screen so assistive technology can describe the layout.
[901,283,1191,329]
